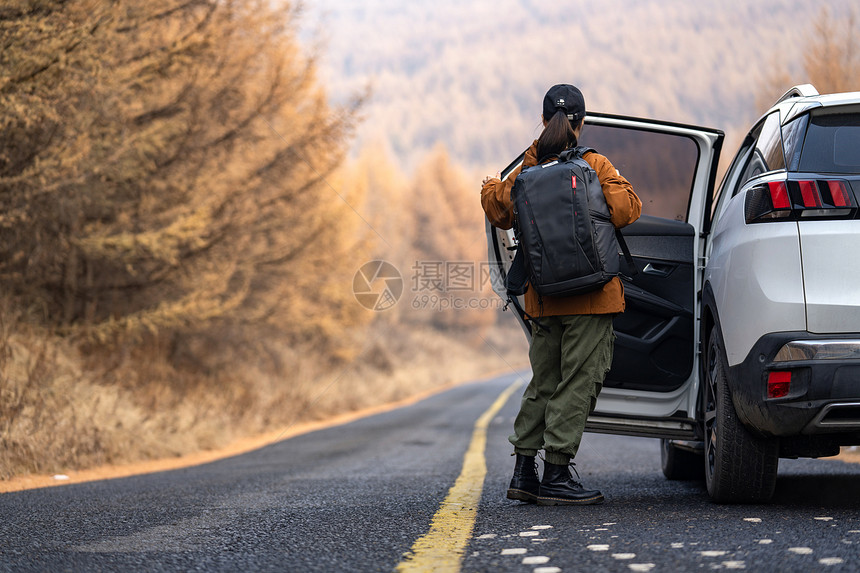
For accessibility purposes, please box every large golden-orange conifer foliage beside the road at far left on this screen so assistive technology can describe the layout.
[0,0,360,340]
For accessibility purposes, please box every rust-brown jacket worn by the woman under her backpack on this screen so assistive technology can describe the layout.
[481,141,642,317]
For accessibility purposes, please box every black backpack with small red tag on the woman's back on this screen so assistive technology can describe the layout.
[506,147,635,296]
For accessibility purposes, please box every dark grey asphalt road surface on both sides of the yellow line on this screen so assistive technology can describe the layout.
[0,370,860,573]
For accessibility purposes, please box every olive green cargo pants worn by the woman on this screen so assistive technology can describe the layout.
[509,314,615,465]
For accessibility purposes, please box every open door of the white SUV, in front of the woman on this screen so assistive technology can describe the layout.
[486,114,724,439]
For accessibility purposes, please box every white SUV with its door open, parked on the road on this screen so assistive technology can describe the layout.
[487,86,860,502]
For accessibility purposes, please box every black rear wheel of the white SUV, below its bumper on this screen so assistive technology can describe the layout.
[703,326,779,503]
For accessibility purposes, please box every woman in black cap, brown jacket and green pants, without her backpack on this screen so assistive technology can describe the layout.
[481,84,642,505]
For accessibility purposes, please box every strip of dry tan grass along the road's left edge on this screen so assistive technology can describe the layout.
[0,309,527,479]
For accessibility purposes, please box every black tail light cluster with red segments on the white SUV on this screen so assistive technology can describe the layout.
[745,179,857,223]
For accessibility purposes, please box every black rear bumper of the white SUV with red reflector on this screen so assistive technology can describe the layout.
[729,332,860,438]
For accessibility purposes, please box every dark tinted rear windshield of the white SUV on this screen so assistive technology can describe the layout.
[798,113,860,173]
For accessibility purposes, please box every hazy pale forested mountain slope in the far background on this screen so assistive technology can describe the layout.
[304,0,855,168]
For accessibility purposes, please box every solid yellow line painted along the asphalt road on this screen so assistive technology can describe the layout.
[397,380,522,572]
